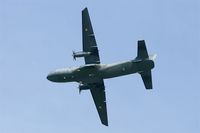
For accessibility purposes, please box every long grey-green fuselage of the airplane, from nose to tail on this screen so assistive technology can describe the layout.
[47,59,154,83]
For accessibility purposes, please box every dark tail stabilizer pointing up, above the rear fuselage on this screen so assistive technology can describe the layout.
[137,40,149,59]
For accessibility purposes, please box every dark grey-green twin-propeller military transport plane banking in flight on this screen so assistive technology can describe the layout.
[47,8,156,126]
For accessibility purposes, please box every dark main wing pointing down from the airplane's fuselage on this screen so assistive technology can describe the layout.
[90,80,108,126]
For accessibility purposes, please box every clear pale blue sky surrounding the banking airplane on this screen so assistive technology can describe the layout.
[0,0,200,133]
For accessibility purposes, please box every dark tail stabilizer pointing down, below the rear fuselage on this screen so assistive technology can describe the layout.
[140,70,153,89]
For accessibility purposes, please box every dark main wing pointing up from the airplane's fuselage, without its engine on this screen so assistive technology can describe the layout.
[82,8,100,64]
